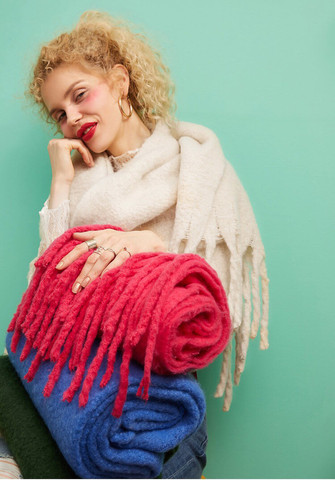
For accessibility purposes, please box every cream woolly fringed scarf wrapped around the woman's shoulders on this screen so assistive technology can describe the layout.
[70,122,269,411]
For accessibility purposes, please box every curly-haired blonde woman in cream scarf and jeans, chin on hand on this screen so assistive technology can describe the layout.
[1,8,268,478]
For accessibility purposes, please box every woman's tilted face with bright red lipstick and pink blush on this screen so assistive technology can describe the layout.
[41,64,128,153]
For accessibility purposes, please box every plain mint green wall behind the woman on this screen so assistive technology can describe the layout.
[0,0,335,478]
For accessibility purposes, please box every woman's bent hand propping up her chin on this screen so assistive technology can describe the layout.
[48,138,94,184]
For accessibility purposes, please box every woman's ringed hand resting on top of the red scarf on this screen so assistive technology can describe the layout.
[56,228,166,293]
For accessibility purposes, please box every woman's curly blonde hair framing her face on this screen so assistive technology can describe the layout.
[27,11,175,129]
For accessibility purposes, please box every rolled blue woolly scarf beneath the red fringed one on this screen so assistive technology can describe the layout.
[7,333,205,478]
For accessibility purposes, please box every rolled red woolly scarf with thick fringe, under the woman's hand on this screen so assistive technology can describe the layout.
[8,225,231,417]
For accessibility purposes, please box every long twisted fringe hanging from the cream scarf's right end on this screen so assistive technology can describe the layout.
[214,207,269,411]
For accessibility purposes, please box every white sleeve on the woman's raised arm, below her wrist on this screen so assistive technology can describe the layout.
[28,197,70,284]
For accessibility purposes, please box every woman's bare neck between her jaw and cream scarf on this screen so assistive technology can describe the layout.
[107,112,151,157]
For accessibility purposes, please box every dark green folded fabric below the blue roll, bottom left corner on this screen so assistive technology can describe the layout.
[0,355,77,478]
